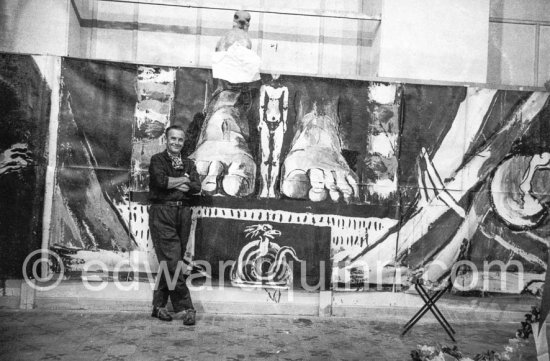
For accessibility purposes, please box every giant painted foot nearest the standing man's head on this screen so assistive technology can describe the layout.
[189,91,256,197]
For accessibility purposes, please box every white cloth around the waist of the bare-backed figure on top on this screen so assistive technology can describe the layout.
[212,43,261,83]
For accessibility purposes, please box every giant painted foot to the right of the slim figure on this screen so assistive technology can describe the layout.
[281,104,359,202]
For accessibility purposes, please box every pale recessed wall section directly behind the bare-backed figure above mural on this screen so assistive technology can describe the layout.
[64,0,381,77]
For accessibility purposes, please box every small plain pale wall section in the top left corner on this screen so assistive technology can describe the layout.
[0,0,69,56]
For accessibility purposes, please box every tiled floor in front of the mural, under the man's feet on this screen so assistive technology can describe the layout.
[0,310,536,361]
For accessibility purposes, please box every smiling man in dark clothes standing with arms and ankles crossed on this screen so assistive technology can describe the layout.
[149,125,201,325]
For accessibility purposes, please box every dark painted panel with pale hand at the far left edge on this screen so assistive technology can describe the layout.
[0,54,51,278]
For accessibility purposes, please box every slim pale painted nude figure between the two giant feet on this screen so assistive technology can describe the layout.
[258,78,288,198]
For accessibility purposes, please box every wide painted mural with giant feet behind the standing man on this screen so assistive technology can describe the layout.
[52,60,550,292]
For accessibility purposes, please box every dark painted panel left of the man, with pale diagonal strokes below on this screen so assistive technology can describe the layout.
[50,59,137,251]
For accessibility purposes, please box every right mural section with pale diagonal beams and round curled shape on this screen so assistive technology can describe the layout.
[353,86,550,292]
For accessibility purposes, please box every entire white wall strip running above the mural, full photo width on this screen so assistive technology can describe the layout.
[0,0,550,87]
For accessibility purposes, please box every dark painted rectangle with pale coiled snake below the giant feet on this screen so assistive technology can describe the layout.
[195,215,332,289]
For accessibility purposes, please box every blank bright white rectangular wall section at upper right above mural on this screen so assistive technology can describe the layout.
[378,0,489,83]
